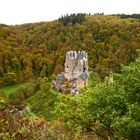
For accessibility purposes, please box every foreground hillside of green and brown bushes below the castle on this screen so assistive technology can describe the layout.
[0,56,140,140]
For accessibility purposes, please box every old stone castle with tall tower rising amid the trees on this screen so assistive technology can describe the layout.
[53,51,88,94]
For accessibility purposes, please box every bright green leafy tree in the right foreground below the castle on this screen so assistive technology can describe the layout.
[55,54,140,140]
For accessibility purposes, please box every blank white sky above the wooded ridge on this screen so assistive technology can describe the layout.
[0,0,140,24]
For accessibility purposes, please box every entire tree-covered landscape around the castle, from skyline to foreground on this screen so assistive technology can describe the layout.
[0,14,140,140]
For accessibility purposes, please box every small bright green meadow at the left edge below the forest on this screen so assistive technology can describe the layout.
[0,83,29,97]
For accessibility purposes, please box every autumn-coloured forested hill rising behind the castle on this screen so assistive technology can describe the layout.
[0,15,140,86]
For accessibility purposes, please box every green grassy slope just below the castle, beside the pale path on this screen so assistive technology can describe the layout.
[26,90,59,123]
